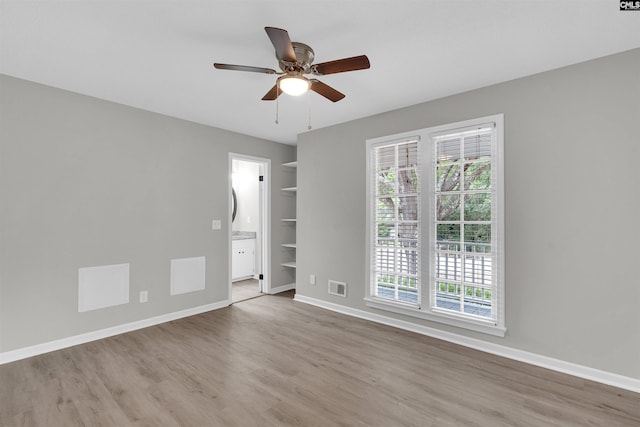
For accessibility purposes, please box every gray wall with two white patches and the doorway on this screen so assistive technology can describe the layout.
[0,75,295,352]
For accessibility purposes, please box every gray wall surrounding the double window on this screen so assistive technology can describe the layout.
[297,49,640,378]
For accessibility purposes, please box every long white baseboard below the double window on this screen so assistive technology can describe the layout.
[294,294,640,393]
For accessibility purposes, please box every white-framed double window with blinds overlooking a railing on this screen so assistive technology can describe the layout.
[366,115,505,336]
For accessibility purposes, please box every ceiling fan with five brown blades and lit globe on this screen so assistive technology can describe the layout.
[213,27,370,102]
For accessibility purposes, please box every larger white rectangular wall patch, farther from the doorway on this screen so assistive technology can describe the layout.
[78,264,129,312]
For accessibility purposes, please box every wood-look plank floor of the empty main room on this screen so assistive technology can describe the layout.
[0,293,640,427]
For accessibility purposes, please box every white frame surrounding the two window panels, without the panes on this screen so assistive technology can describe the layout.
[365,114,506,337]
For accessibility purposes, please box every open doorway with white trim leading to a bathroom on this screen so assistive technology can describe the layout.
[228,153,271,303]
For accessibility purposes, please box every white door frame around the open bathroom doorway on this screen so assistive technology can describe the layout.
[227,153,271,301]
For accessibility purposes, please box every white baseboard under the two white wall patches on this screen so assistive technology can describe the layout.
[0,300,229,365]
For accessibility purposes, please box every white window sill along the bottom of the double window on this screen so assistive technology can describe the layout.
[365,297,507,337]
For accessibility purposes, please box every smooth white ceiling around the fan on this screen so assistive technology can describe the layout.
[0,0,640,144]
